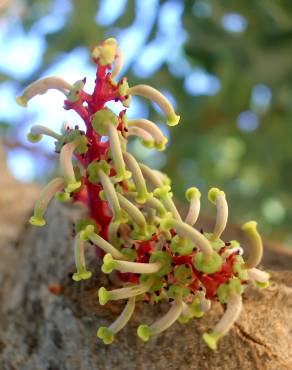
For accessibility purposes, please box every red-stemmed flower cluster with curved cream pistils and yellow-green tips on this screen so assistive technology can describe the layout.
[17,38,269,349]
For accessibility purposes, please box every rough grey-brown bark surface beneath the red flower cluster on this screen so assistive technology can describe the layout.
[0,149,292,370]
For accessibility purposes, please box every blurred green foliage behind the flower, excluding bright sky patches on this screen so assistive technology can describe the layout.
[0,0,292,244]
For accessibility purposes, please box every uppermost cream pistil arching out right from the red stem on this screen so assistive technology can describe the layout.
[129,85,180,126]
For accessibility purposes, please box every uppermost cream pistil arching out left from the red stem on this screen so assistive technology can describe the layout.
[16,77,72,107]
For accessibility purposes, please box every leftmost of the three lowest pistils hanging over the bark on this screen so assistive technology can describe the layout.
[97,297,136,344]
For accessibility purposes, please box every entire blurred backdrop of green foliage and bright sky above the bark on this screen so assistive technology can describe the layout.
[0,0,292,247]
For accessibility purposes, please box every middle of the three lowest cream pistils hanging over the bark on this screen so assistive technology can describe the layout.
[137,299,183,342]
